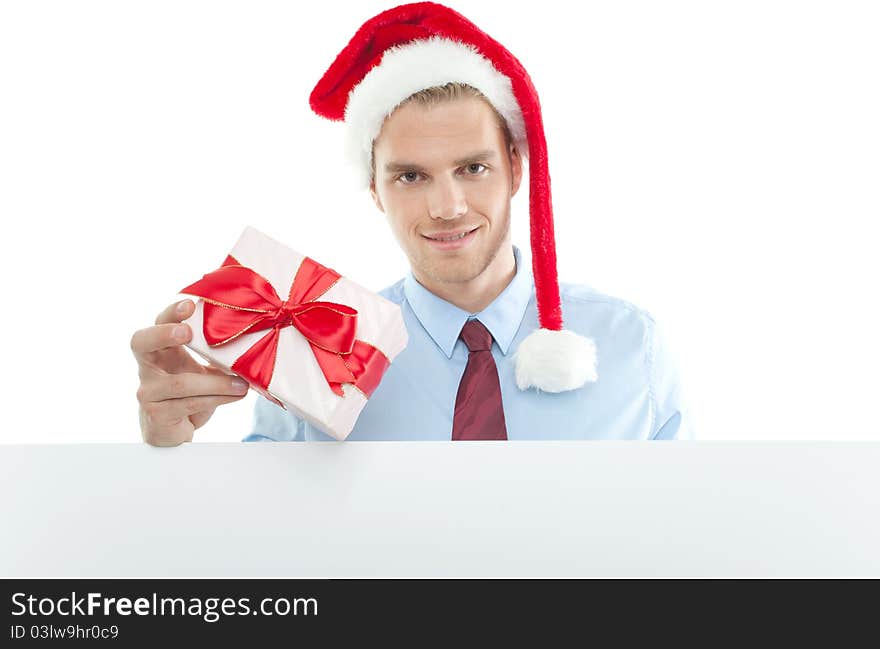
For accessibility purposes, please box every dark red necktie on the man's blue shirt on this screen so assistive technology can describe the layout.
[452,320,507,440]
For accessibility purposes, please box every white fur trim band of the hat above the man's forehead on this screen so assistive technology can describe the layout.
[345,36,528,188]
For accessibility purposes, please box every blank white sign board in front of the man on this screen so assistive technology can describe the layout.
[0,441,880,578]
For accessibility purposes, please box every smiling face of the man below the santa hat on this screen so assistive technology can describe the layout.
[371,97,522,284]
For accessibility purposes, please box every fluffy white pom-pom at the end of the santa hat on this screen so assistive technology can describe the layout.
[514,329,599,392]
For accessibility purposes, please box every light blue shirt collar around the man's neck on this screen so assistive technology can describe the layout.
[403,246,533,358]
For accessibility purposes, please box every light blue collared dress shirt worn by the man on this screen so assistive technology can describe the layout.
[243,246,694,442]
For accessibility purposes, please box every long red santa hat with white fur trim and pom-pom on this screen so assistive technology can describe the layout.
[309,2,597,392]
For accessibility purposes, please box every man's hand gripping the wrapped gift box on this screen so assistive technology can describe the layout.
[131,300,248,446]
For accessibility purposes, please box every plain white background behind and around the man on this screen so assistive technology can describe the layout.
[0,0,880,442]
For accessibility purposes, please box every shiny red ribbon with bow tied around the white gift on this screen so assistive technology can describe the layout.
[180,255,388,397]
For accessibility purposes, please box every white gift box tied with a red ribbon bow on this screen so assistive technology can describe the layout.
[180,227,408,441]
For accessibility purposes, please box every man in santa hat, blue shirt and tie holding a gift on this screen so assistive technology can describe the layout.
[132,3,693,445]
